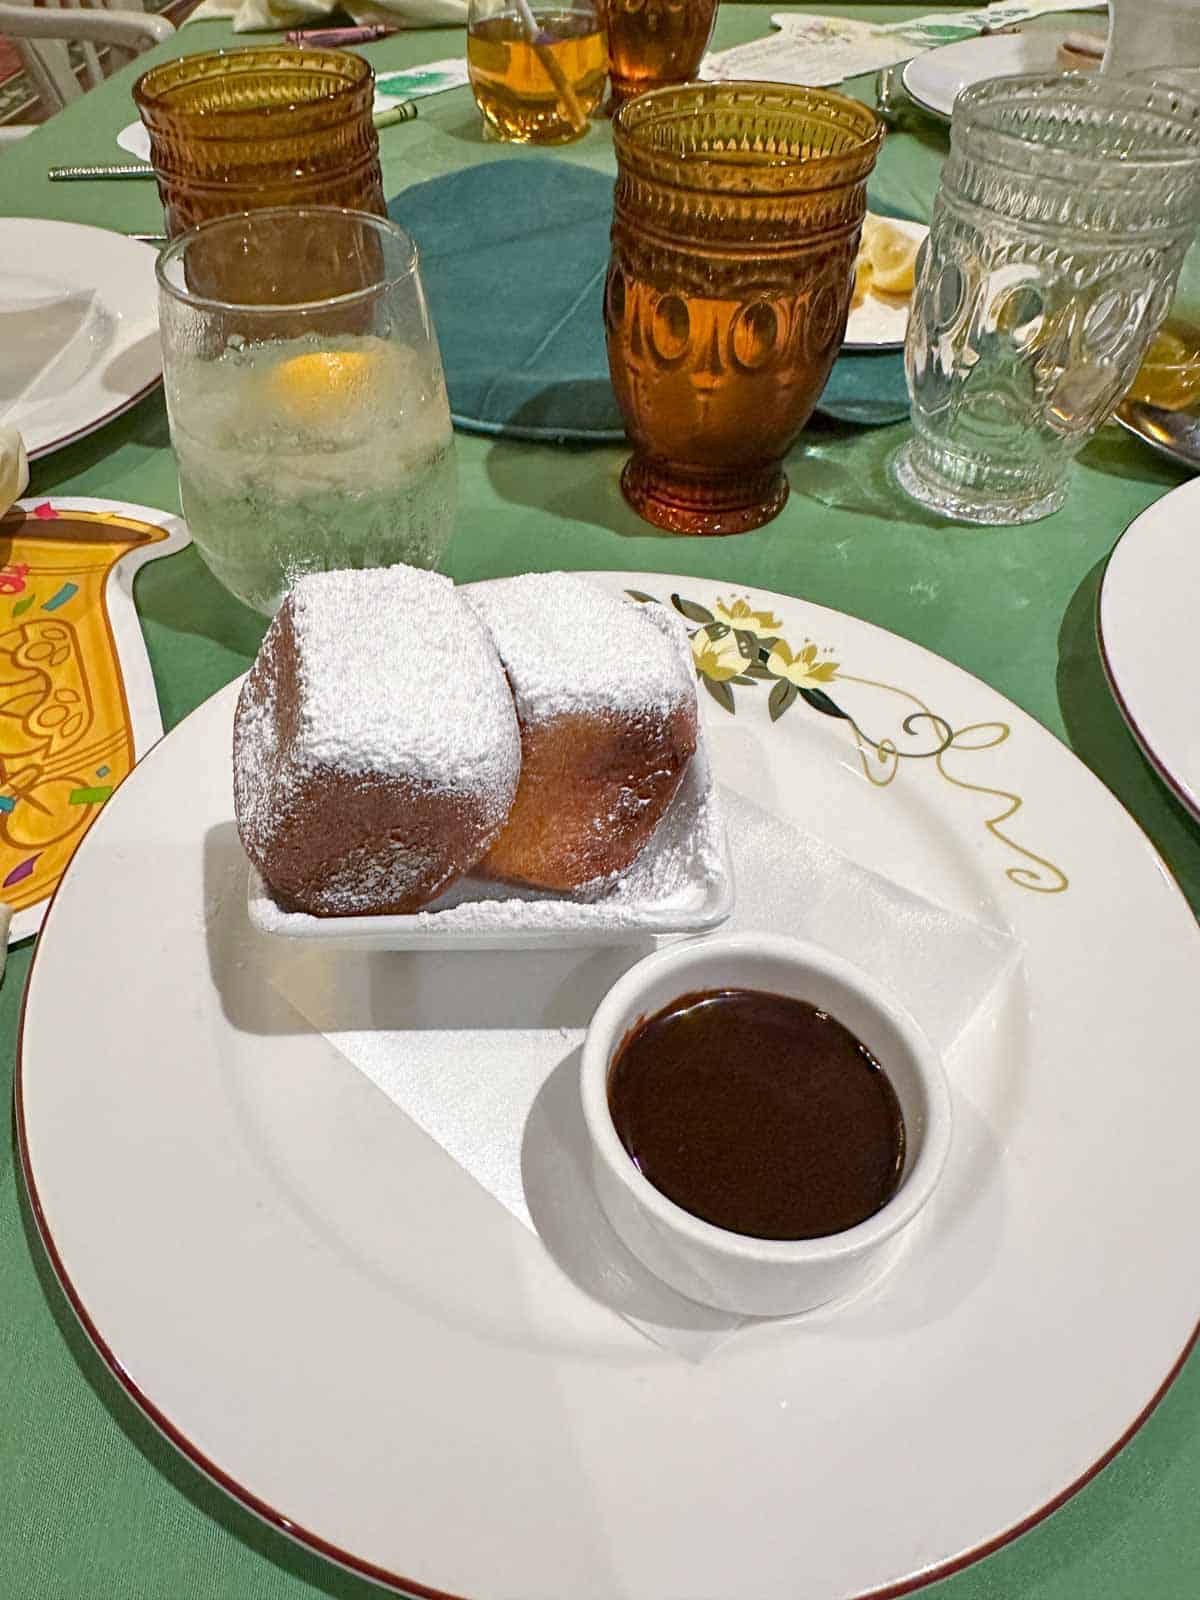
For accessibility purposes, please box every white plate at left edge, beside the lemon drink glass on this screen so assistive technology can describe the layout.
[0,216,162,459]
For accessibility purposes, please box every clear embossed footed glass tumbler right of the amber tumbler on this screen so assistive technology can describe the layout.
[891,74,1200,523]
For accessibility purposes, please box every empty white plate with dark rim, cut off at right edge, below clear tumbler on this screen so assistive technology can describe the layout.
[1098,480,1200,818]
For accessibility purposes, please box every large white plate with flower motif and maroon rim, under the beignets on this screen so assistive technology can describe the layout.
[16,574,1200,1600]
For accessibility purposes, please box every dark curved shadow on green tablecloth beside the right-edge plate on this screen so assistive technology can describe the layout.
[1056,557,1200,909]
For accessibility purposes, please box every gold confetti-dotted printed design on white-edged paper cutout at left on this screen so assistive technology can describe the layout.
[0,510,168,910]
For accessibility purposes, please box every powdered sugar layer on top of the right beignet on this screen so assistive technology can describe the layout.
[461,573,696,723]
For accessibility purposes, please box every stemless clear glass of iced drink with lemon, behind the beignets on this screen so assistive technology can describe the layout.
[158,206,456,614]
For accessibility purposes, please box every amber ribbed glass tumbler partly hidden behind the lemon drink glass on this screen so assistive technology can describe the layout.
[133,46,386,238]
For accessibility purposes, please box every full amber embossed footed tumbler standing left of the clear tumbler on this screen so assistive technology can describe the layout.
[605,83,883,533]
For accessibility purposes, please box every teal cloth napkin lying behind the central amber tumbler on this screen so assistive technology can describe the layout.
[387,160,909,443]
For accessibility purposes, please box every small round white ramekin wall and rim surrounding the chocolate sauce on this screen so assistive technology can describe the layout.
[581,934,950,1317]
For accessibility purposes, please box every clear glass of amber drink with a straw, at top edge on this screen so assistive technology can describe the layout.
[467,0,608,144]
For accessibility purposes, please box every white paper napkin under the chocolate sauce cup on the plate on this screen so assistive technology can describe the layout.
[270,792,1018,1360]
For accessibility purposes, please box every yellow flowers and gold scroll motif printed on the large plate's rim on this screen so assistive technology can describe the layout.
[627,589,1069,894]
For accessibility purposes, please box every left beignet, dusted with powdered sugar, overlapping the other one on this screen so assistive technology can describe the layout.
[234,566,520,917]
